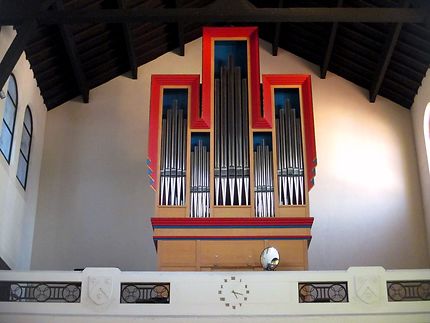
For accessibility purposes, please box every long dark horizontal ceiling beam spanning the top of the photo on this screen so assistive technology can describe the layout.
[0,7,429,25]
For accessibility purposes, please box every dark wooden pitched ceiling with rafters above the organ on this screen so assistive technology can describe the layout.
[0,0,430,110]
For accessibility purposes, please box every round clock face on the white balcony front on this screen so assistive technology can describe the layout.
[218,276,249,310]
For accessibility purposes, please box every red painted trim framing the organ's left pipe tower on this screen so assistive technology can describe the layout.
[147,75,200,191]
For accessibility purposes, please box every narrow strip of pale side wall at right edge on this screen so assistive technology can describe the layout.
[412,71,430,250]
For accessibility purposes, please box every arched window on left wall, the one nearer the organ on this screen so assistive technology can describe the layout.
[16,105,33,189]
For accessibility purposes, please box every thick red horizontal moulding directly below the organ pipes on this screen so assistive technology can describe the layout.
[151,217,314,227]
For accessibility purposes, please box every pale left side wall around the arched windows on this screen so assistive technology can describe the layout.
[0,27,46,269]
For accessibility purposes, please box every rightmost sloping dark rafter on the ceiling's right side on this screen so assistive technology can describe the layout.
[369,0,409,103]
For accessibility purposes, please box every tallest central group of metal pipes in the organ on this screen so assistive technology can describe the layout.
[214,56,249,205]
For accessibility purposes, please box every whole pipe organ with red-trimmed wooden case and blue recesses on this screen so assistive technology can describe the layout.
[148,27,316,271]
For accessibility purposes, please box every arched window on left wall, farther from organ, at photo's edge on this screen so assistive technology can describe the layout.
[0,74,18,163]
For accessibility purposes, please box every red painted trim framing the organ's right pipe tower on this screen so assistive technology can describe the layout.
[262,74,317,190]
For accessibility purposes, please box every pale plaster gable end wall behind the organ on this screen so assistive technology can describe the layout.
[32,39,429,270]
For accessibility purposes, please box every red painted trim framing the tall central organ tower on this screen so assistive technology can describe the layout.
[202,27,262,128]
